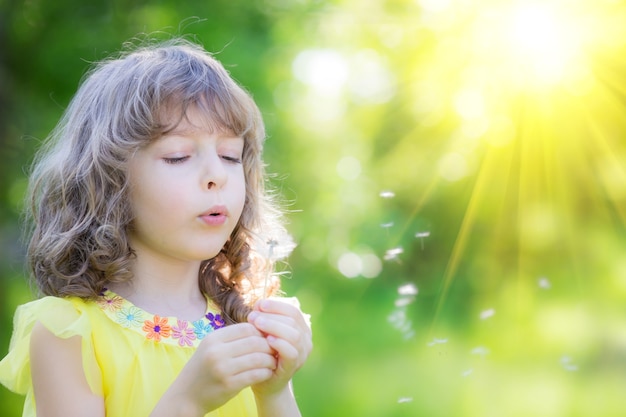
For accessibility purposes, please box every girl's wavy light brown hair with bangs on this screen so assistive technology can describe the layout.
[26,39,291,324]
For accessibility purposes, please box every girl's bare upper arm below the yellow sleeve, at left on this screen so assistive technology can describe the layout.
[30,322,104,417]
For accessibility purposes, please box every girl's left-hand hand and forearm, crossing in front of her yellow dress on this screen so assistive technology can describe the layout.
[151,323,276,416]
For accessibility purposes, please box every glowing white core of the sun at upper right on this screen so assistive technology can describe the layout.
[473,1,586,88]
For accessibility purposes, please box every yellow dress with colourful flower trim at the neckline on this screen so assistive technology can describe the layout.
[0,291,257,417]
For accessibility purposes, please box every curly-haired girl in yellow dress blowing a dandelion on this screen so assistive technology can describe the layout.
[0,40,312,417]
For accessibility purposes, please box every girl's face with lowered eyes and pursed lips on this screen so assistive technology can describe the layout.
[129,109,246,261]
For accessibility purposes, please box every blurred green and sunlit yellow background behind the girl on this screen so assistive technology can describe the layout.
[0,0,626,417]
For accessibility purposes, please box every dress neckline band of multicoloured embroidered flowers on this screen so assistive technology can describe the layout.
[96,288,225,348]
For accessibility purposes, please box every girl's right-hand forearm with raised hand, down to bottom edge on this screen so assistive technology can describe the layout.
[248,300,313,417]
